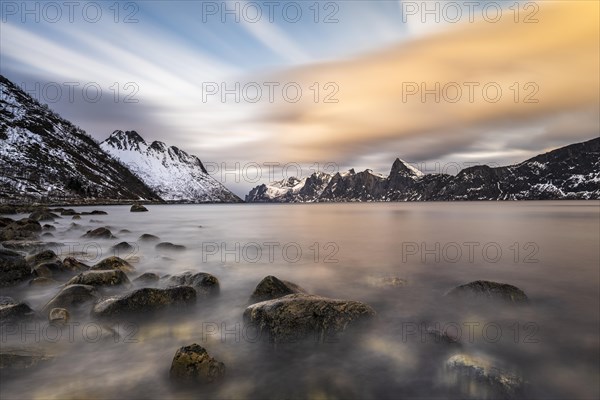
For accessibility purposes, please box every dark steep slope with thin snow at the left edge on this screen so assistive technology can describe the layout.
[0,75,160,202]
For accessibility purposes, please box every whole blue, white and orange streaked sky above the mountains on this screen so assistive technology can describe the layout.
[0,0,600,196]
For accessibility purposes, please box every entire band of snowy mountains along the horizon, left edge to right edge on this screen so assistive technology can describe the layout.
[0,75,600,203]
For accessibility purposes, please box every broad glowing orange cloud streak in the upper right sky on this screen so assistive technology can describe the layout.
[268,1,600,160]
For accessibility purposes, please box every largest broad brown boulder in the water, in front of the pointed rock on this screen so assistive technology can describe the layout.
[244,294,376,343]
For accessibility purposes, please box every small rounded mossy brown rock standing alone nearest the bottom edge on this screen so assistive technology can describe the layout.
[169,343,225,384]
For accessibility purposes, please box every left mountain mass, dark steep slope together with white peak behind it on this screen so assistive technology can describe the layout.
[0,75,241,203]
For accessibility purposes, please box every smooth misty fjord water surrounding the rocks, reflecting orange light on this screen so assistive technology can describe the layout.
[0,201,600,399]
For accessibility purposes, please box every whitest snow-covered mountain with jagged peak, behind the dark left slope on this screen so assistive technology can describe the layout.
[100,130,241,203]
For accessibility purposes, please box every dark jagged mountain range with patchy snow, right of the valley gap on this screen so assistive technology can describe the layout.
[246,138,600,203]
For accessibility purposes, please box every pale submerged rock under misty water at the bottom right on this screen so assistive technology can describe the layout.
[446,354,525,399]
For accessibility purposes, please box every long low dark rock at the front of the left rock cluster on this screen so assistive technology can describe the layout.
[92,286,196,318]
